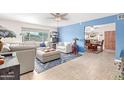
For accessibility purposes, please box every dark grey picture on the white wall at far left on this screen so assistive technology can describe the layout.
[0,26,16,38]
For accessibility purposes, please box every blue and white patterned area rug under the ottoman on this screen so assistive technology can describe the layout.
[35,53,81,73]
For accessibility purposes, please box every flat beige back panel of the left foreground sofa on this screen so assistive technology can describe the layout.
[10,46,36,74]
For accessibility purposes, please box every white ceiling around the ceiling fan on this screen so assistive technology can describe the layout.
[0,13,115,26]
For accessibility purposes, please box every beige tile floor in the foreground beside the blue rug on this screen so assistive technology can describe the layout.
[21,52,118,80]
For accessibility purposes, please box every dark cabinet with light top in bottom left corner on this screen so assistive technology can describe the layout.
[0,56,20,80]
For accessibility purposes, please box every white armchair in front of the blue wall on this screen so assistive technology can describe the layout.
[56,42,72,53]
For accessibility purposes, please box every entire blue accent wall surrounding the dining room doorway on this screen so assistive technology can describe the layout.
[58,15,124,59]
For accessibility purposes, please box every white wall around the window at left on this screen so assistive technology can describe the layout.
[0,19,57,42]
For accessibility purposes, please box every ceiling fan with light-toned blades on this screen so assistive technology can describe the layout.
[49,13,68,22]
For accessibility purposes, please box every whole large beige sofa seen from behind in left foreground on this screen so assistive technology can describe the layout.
[2,44,36,74]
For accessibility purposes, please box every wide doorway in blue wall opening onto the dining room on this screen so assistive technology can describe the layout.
[85,23,116,53]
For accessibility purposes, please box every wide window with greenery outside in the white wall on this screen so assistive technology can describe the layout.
[22,28,49,42]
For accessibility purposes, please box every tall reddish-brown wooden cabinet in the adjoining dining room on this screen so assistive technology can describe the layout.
[105,31,115,50]
